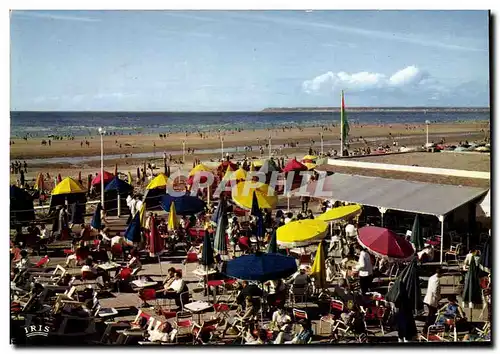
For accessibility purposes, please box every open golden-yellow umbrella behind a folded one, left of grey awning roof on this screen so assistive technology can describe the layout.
[231,181,278,210]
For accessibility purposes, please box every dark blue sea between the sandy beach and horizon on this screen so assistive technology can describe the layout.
[10,110,490,138]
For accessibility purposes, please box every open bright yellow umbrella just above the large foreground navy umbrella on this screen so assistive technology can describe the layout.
[276,219,328,248]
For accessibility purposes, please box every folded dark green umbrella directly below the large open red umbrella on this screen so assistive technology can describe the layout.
[386,257,424,313]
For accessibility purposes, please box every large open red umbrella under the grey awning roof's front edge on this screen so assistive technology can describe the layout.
[358,226,415,261]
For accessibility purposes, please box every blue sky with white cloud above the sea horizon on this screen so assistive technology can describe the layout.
[10,11,489,111]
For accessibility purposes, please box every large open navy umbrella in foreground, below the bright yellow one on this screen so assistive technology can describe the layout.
[226,252,297,283]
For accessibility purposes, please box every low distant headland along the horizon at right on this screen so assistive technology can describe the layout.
[262,107,490,113]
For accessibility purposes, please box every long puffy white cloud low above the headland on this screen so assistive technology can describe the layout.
[302,65,429,94]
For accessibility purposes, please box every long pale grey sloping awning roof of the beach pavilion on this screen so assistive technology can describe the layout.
[293,173,488,216]
